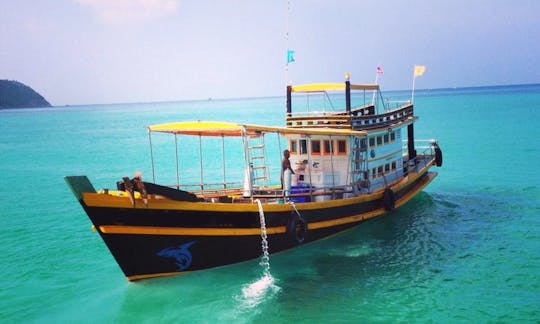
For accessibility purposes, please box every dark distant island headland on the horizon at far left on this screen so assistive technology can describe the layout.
[0,80,51,109]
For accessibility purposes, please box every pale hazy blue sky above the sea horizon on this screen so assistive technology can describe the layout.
[0,0,540,105]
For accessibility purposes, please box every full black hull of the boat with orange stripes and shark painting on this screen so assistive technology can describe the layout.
[67,172,436,280]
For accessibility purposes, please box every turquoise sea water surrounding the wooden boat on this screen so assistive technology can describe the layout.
[0,85,540,323]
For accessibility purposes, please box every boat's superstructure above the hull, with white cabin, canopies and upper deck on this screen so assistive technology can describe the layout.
[148,80,436,202]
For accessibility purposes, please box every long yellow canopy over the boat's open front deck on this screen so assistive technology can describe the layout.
[148,120,366,136]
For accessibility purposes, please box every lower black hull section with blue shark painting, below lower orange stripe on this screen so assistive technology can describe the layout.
[96,223,357,280]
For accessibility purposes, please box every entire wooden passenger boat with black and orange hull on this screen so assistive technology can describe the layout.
[65,75,442,281]
